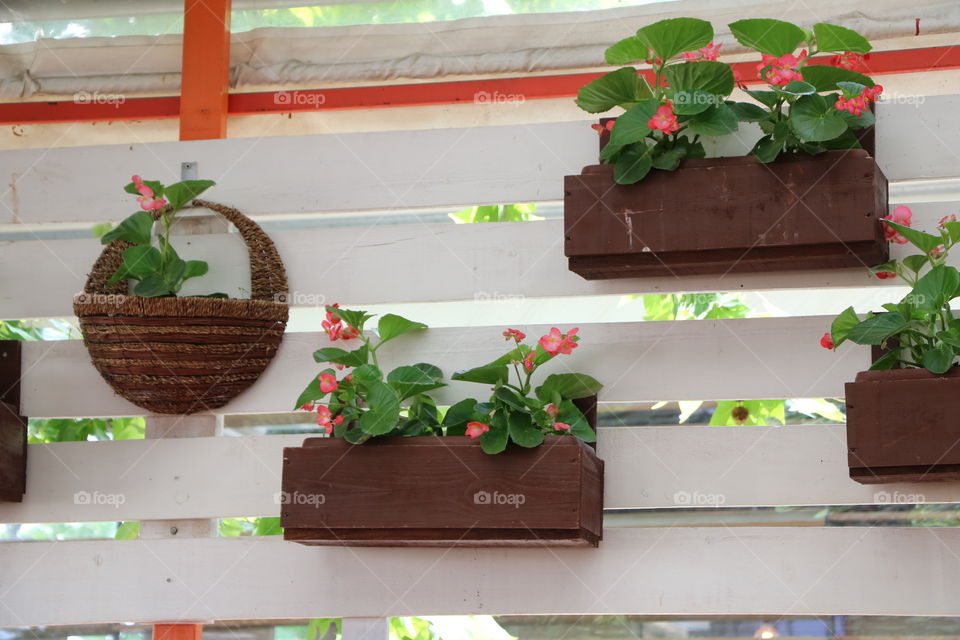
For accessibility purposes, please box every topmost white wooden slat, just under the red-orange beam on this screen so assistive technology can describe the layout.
[0,95,960,223]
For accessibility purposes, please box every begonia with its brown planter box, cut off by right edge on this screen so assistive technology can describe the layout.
[820,206,960,484]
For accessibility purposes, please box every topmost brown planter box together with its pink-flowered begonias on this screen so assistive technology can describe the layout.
[564,18,889,279]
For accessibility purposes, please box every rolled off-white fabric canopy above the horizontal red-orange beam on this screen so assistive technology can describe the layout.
[0,0,960,100]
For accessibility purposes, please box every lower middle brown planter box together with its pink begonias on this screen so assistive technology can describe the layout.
[280,305,603,546]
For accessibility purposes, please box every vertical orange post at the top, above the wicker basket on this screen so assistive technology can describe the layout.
[180,0,231,140]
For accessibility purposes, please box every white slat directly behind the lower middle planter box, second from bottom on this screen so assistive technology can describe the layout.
[0,425,960,523]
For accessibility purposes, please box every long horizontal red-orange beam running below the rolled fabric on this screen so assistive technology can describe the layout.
[0,46,960,126]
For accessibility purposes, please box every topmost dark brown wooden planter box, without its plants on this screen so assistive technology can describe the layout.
[564,149,889,280]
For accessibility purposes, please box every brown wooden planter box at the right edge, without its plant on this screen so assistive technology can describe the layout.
[845,368,960,484]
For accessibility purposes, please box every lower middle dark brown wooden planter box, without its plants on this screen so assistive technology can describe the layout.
[280,436,603,547]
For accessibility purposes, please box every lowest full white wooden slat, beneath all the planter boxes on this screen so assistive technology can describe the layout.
[0,527,960,626]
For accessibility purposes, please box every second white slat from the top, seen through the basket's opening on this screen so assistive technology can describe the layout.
[0,201,960,318]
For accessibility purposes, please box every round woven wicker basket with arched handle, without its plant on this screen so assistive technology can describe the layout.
[73,200,288,414]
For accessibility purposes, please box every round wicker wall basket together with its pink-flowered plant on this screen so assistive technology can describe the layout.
[73,175,288,414]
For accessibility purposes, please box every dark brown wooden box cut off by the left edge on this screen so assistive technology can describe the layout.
[0,340,27,502]
